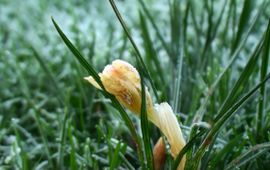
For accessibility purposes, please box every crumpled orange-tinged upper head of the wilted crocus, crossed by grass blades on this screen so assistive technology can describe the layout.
[85,60,153,119]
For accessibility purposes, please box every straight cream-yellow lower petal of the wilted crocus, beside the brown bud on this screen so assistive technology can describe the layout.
[153,103,186,170]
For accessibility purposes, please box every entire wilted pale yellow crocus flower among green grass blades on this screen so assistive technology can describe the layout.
[84,60,185,170]
